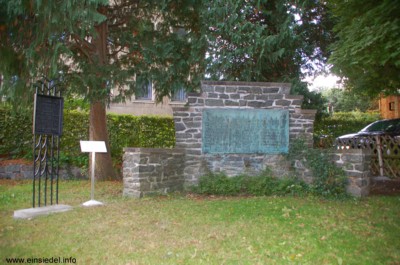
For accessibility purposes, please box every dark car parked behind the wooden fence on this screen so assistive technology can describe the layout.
[336,119,400,148]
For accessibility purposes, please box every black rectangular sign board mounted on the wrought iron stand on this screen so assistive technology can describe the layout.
[33,94,64,136]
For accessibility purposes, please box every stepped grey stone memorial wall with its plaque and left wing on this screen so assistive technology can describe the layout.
[123,81,315,197]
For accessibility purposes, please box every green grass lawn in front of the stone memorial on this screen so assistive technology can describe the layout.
[0,180,400,265]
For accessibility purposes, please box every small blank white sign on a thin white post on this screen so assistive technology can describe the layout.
[80,141,107,206]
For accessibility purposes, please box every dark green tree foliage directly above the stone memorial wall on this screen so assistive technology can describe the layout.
[204,0,332,82]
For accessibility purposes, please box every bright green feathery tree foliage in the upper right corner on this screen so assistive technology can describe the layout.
[330,0,400,97]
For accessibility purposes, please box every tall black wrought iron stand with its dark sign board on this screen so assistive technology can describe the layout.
[32,78,63,207]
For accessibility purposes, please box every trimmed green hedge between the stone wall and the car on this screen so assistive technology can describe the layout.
[314,111,380,147]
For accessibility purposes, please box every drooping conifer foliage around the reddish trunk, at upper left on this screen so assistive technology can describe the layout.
[0,0,204,102]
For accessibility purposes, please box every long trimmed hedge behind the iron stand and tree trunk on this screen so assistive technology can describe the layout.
[0,106,175,166]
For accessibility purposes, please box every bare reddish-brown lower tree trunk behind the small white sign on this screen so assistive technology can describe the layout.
[89,102,116,180]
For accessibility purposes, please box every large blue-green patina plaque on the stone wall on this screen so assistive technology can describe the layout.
[202,109,289,154]
